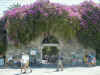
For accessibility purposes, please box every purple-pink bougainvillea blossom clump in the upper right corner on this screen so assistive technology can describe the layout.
[80,2,100,29]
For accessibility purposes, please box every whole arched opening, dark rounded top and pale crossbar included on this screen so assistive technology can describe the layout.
[41,34,59,64]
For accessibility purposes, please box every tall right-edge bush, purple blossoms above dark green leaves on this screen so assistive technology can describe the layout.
[78,3,100,50]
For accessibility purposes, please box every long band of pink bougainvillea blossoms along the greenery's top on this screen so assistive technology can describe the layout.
[2,1,100,29]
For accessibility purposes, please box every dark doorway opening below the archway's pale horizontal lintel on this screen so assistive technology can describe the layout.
[42,46,59,64]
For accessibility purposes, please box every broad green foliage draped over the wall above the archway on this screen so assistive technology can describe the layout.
[8,3,79,44]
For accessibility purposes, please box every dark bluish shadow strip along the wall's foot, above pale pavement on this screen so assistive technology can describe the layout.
[0,64,97,69]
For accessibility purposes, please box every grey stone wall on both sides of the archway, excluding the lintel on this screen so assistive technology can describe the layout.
[6,38,95,64]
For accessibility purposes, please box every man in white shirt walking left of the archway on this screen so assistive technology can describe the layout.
[21,53,32,73]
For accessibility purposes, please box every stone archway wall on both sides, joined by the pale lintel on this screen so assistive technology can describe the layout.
[6,32,95,64]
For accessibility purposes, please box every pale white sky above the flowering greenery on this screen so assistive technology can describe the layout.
[0,0,100,17]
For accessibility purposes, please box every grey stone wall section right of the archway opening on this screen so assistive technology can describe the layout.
[58,39,96,64]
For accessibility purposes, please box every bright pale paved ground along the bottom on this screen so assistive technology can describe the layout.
[0,66,100,75]
